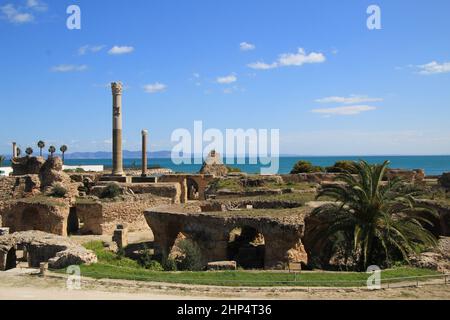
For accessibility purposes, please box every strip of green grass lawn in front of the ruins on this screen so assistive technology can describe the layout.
[62,241,439,287]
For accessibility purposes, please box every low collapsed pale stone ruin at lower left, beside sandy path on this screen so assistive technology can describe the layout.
[0,231,97,269]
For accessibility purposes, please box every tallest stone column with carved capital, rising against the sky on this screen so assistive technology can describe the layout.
[111,82,124,176]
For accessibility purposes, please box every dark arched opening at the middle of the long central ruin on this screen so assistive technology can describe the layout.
[227,226,266,269]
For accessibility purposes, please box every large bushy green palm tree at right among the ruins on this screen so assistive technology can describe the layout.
[311,161,436,270]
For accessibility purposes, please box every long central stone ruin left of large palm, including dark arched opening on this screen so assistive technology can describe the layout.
[144,204,308,269]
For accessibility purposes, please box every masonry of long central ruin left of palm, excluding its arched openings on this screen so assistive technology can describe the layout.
[145,206,307,269]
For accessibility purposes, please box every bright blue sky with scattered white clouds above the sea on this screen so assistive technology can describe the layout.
[0,0,450,155]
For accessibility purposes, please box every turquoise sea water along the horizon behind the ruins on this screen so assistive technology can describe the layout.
[66,156,450,175]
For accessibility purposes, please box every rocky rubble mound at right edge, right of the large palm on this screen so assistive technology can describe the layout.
[410,237,450,273]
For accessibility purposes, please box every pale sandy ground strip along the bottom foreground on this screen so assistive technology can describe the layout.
[0,269,450,300]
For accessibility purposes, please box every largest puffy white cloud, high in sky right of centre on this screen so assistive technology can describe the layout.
[247,48,326,70]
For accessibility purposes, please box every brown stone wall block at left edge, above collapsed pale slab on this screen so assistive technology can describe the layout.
[0,197,70,236]
